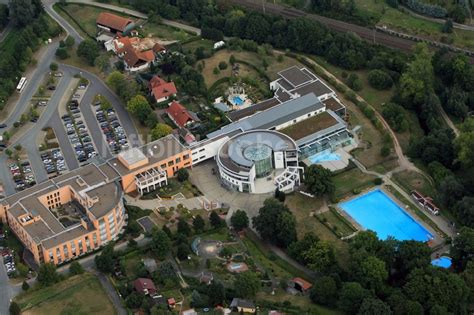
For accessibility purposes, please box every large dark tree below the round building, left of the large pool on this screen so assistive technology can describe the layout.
[252,198,296,248]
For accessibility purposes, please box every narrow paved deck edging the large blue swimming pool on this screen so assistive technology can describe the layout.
[335,185,444,248]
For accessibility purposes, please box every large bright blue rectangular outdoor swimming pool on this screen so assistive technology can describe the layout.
[339,189,433,242]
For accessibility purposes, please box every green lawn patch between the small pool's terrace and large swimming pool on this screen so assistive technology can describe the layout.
[333,168,375,199]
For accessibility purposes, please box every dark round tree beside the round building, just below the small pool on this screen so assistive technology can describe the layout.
[304,164,335,196]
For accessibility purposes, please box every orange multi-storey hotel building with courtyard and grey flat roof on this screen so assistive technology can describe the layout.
[0,135,192,264]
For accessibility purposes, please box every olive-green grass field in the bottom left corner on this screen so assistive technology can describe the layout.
[15,273,115,315]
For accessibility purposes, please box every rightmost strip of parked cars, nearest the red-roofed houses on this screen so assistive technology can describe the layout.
[91,99,129,154]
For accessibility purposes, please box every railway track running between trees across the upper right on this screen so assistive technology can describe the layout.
[229,0,474,59]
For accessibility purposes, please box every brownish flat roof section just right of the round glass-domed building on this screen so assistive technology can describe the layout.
[279,112,338,140]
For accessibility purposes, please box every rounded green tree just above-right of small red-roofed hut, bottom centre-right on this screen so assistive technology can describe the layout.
[303,241,336,273]
